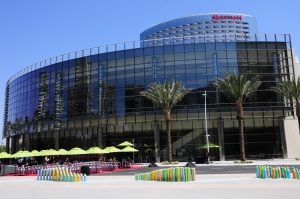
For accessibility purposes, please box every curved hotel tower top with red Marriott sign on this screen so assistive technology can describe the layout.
[140,13,257,46]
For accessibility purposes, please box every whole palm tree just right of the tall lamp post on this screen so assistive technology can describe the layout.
[214,73,262,161]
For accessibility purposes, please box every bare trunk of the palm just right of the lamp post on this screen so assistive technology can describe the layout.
[236,100,246,161]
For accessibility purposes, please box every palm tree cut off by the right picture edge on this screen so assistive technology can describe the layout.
[271,77,300,128]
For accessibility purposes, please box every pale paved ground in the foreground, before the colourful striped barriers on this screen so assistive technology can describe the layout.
[0,173,300,199]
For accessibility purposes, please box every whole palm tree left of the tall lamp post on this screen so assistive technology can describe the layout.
[140,81,190,162]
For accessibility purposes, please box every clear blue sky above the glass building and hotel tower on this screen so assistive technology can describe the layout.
[0,0,300,143]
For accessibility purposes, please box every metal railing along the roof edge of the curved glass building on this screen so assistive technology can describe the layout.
[8,34,291,82]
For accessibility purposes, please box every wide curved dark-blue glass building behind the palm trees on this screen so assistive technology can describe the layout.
[3,14,294,161]
